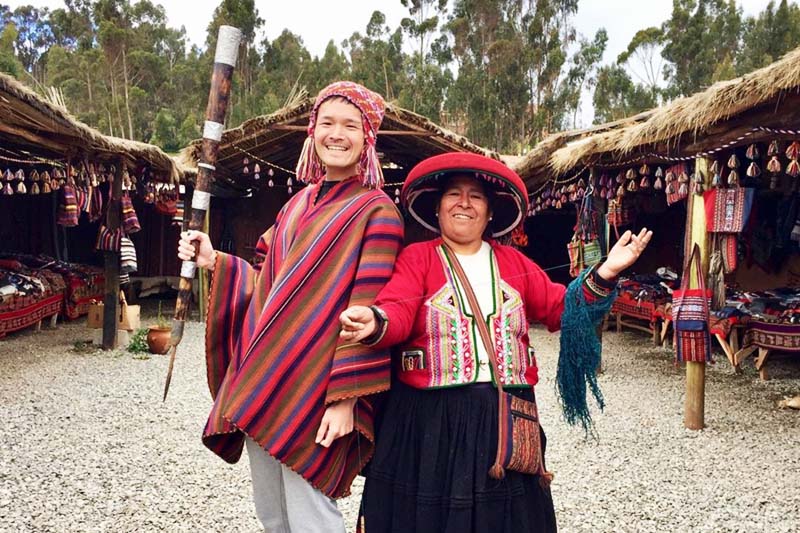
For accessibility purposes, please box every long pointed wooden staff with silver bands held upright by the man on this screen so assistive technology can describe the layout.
[164,26,242,400]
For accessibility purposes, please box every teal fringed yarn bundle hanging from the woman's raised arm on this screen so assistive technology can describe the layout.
[556,269,617,435]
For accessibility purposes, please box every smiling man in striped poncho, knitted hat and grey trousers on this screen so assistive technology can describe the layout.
[178,82,403,533]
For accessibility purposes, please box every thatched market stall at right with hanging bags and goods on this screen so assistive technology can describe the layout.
[517,46,800,390]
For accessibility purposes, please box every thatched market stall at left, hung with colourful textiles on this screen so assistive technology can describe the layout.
[0,74,180,344]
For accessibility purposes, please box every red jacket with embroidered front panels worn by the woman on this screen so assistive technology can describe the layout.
[375,239,566,388]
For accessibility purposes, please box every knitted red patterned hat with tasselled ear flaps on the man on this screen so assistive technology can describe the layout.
[297,81,386,189]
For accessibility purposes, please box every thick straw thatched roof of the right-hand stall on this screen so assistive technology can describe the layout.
[517,48,800,189]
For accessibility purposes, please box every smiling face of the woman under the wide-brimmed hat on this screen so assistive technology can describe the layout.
[438,176,491,245]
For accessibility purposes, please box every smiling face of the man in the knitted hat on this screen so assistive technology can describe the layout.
[314,98,364,180]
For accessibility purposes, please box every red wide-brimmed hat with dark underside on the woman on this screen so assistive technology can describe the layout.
[400,152,528,237]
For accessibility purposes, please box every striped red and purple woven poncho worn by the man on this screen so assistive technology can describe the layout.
[203,179,403,498]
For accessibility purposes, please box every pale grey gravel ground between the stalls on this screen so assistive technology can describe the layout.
[0,312,800,533]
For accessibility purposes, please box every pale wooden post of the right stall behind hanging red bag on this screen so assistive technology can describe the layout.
[683,158,711,429]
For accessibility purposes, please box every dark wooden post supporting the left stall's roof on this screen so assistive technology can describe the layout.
[103,157,125,350]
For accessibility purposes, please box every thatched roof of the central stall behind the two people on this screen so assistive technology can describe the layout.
[178,96,500,188]
